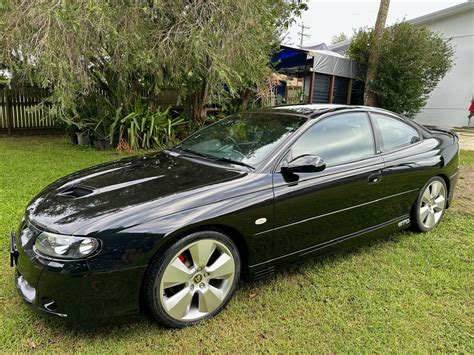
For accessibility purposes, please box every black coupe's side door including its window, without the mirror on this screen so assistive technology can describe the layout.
[273,111,385,256]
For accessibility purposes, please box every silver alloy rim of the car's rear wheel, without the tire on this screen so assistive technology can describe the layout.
[418,180,446,229]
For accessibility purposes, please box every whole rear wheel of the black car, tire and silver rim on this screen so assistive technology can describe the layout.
[411,176,448,232]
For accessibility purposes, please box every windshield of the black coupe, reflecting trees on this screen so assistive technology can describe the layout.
[176,113,306,166]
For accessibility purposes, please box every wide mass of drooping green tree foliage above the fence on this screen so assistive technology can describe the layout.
[0,0,305,119]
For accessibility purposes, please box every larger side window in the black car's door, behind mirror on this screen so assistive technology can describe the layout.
[291,112,375,166]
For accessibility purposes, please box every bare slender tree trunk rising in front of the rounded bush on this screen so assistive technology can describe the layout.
[364,0,390,106]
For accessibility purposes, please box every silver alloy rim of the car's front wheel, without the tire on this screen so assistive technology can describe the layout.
[156,239,236,321]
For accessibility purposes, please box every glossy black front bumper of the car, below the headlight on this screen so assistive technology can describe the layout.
[10,228,145,322]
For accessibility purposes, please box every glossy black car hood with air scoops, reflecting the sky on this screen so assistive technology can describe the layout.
[26,152,247,235]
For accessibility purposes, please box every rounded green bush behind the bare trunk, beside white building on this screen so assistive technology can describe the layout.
[348,22,454,117]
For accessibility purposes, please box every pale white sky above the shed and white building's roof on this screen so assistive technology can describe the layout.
[284,0,465,46]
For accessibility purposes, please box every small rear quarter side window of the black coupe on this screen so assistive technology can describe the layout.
[371,113,420,151]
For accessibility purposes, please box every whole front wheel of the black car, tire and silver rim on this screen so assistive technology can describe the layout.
[144,231,241,328]
